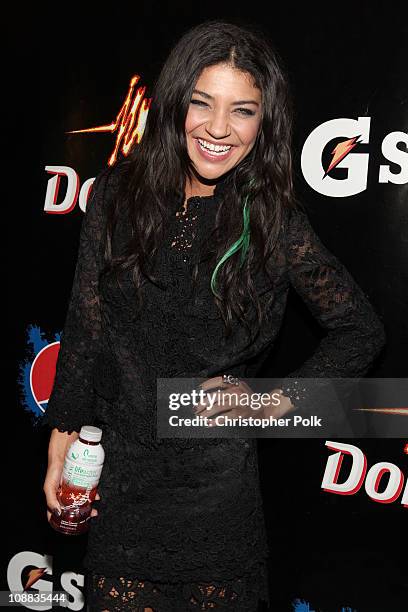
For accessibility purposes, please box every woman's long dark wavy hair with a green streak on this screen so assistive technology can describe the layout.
[105,21,295,342]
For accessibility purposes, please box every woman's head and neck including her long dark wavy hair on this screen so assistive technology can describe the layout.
[99,22,295,343]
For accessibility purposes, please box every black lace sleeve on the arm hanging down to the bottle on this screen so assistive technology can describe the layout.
[43,171,111,432]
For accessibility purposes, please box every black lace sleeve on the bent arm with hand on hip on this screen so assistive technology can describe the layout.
[285,204,385,378]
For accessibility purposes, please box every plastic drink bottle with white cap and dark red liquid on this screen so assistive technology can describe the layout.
[50,425,105,535]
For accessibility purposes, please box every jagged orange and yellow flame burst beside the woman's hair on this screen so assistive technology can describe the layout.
[67,74,152,166]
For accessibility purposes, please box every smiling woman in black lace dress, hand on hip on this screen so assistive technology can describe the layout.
[44,16,384,612]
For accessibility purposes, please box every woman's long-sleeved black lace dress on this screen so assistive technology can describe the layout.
[44,165,384,612]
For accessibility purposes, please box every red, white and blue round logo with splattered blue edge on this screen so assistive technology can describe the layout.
[18,325,61,420]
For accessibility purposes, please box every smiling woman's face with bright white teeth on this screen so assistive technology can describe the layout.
[185,64,262,180]
